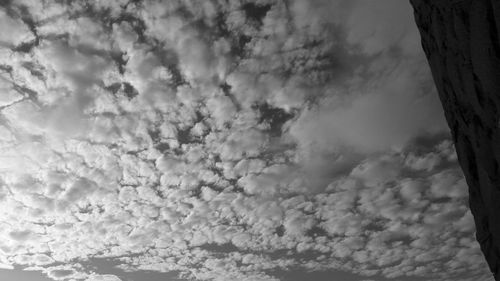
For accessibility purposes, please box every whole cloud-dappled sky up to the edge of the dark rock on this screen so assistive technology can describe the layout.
[0,0,492,281]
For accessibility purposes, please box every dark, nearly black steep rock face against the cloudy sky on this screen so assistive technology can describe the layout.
[410,0,500,280]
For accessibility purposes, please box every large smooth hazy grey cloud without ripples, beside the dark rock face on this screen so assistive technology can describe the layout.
[290,53,448,153]
